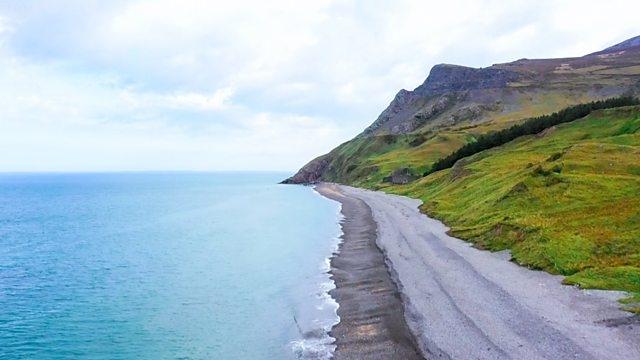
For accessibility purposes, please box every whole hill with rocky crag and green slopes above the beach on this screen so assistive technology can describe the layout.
[284,37,640,306]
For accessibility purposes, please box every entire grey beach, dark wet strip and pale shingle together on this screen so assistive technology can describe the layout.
[318,184,640,359]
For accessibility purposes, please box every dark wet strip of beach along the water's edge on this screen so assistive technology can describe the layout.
[315,184,422,359]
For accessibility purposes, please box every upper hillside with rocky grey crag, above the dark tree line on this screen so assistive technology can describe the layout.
[284,36,640,185]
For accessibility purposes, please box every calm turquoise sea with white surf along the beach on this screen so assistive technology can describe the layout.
[0,173,339,359]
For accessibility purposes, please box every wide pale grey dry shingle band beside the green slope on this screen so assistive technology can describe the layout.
[318,184,640,359]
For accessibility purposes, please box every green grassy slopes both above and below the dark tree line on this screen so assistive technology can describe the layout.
[308,58,640,312]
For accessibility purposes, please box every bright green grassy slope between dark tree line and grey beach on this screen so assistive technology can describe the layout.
[384,107,640,310]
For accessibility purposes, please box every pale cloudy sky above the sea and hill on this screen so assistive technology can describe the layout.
[0,0,640,172]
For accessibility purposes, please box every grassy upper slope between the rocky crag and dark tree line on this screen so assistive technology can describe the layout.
[324,49,640,189]
